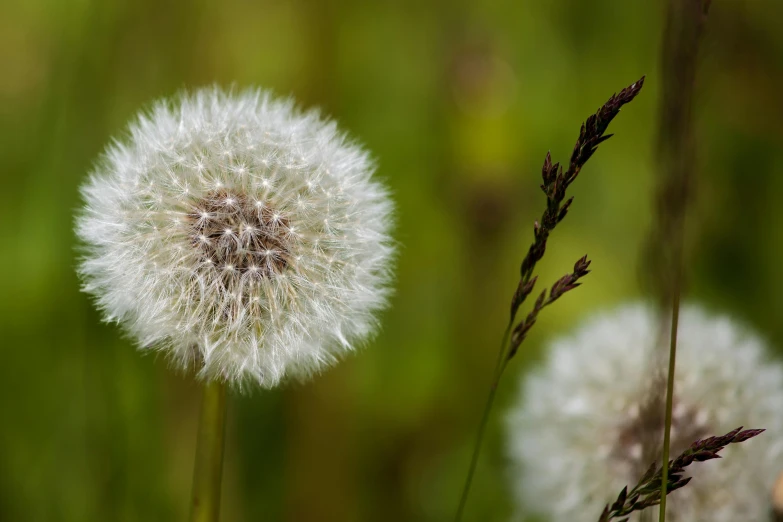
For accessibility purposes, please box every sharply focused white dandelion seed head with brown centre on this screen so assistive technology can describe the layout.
[77,88,394,388]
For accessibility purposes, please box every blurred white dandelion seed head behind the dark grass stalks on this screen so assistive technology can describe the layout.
[508,305,783,522]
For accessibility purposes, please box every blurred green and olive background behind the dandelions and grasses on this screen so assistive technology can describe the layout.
[0,0,783,522]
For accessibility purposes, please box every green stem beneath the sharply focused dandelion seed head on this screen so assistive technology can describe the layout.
[190,381,226,522]
